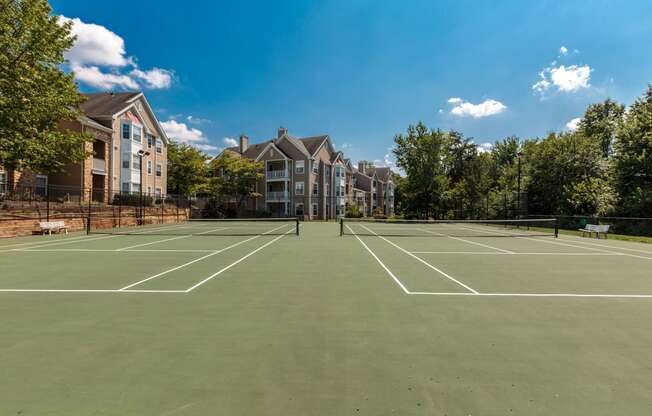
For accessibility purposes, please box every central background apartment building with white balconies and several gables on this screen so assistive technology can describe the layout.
[218,127,394,219]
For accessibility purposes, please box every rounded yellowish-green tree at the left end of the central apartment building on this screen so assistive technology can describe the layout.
[209,152,264,211]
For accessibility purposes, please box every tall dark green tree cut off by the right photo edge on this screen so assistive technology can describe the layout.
[613,85,652,216]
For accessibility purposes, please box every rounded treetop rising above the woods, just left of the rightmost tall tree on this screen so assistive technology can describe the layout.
[578,98,625,159]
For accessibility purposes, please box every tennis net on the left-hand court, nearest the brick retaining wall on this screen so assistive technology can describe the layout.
[89,218,299,236]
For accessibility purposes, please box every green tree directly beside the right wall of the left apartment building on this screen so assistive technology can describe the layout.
[168,142,209,196]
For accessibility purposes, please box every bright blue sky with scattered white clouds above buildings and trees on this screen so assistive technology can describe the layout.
[51,0,652,164]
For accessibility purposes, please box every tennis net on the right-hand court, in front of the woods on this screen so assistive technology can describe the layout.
[340,218,558,237]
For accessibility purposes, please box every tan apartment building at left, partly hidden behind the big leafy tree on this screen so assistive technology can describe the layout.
[0,92,168,202]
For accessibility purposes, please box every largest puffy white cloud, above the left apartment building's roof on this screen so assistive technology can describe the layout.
[59,16,173,89]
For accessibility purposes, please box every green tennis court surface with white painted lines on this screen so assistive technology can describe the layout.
[0,222,652,416]
